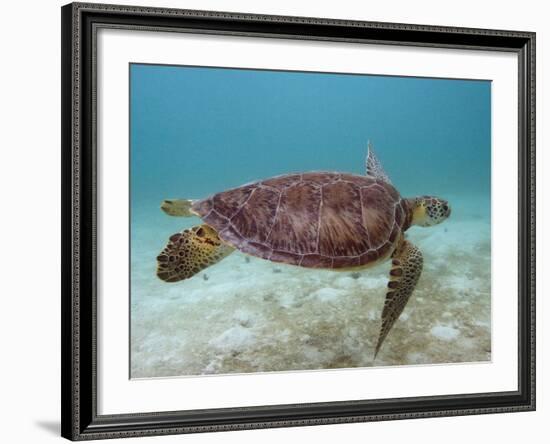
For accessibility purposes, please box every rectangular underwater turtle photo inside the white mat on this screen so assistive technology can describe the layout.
[129,64,491,378]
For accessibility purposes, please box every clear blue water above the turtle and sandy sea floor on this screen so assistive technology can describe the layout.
[130,64,491,205]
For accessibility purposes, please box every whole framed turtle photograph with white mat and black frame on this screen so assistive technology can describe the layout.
[62,3,535,440]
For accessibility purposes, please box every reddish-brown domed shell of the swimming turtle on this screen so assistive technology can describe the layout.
[192,172,407,269]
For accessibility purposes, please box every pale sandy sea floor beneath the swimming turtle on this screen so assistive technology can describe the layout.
[130,196,491,378]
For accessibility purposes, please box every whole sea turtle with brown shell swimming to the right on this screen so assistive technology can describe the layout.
[157,144,451,357]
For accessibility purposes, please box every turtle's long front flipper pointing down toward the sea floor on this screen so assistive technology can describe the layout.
[374,240,423,359]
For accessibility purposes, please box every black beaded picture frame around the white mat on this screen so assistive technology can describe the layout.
[61,3,535,440]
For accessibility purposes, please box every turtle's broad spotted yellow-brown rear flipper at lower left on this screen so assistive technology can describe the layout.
[157,224,234,282]
